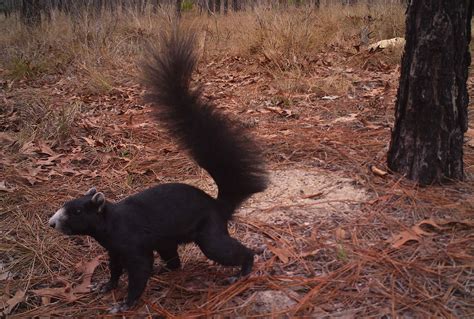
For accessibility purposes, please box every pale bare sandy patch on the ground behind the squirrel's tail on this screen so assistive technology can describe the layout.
[239,169,370,224]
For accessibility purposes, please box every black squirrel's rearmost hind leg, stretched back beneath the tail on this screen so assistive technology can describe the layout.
[196,233,254,276]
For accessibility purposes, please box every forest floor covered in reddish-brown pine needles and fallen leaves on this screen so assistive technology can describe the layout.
[0,7,474,318]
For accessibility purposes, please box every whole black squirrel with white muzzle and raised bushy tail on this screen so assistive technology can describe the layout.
[49,29,267,312]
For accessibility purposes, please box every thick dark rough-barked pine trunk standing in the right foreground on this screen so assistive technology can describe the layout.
[387,0,472,185]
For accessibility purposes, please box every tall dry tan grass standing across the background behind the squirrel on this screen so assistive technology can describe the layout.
[0,5,404,81]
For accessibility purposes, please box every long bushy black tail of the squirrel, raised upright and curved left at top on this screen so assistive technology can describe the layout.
[144,30,267,218]
